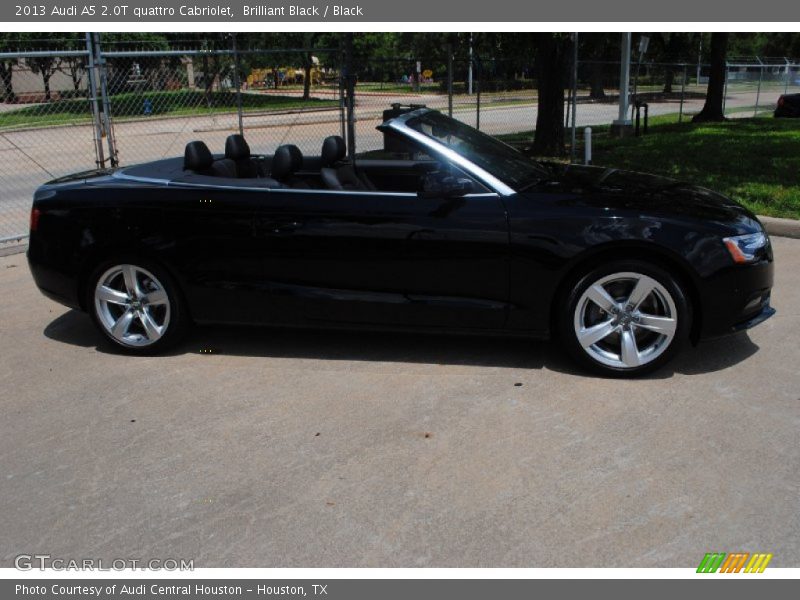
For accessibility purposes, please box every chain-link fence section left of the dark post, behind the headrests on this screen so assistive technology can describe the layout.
[0,36,344,245]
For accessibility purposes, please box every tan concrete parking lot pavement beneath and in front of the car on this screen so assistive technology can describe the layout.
[0,238,800,567]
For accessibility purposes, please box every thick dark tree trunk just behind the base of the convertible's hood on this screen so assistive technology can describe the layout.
[533,33,572,156]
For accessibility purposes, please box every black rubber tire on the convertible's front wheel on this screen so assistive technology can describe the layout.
[555,260,692,377]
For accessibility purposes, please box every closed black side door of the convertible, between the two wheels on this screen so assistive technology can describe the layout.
[256,183,509,329]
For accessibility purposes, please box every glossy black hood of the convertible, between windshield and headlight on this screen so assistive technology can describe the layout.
[536,163,757,228]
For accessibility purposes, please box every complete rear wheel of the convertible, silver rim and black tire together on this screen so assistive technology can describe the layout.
[87,258,187,354]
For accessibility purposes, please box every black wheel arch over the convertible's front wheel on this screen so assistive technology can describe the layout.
[550,242,703,344]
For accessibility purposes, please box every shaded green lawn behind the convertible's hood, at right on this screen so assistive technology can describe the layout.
[501,115,800,219]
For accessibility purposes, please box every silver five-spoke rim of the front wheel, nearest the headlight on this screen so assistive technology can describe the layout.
[573,271,679,371]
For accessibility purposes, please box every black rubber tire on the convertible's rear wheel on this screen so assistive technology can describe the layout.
[85,255,191,356]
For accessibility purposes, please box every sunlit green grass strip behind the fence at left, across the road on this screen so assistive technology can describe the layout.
[0,90,338,130]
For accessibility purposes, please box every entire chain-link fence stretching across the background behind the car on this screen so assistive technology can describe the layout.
[0,34,800,244]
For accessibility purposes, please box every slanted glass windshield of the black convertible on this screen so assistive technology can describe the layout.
[406,112,547,191]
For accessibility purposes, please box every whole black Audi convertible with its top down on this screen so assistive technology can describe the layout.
[28,109,774,375]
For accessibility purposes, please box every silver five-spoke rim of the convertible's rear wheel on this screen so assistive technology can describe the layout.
[94,264,171,348]
